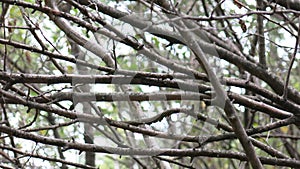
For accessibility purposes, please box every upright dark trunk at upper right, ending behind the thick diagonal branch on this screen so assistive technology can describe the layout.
[256,0,267,68]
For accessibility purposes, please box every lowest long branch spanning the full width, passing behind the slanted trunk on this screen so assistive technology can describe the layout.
[0,126,300,167]
